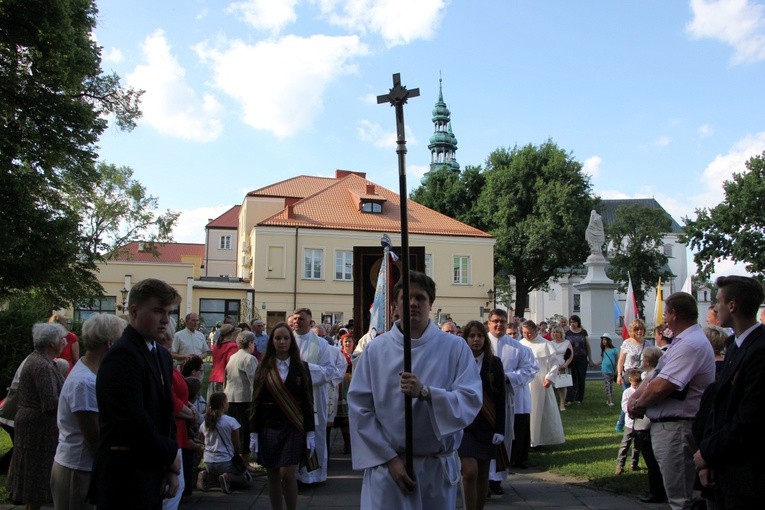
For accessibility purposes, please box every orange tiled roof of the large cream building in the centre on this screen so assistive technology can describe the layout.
[256,173,491,237]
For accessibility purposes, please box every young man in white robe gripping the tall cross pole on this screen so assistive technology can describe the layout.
[348,271,483,510]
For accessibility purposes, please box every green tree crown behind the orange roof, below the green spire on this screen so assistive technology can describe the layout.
[409,166,485,228]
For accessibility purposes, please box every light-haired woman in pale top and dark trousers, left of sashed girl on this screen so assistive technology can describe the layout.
[223,331,258,464]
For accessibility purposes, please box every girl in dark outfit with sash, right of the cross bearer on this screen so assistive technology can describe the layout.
[458,321,507,510]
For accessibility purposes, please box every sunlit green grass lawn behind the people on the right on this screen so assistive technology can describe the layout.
[529,380,648,495]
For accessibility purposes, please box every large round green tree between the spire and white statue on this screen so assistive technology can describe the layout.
[478,140,599,313]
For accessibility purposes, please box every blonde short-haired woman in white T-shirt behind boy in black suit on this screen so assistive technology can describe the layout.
[50,313,127,510]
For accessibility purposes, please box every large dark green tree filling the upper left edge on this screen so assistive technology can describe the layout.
[0,0,141,305]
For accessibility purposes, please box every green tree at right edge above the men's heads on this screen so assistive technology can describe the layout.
[681,151,765,277]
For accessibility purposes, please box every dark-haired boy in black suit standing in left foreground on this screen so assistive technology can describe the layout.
[89,279,181,510]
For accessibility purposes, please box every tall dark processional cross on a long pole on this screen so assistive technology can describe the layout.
[377,73,420,479]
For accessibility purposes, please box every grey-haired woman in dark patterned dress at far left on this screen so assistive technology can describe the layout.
[6,323,66,509]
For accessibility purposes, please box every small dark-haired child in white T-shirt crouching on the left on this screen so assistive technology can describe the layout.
[197,391,252,494]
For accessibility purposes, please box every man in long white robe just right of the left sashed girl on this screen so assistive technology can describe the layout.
[292,308,336,484]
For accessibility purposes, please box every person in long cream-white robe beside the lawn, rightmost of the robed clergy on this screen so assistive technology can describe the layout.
[521,321,566,448]
